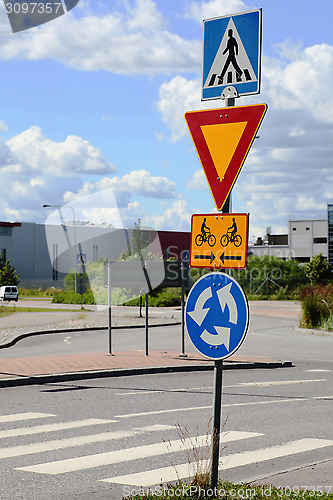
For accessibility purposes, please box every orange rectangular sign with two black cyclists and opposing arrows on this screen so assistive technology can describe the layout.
[190,213,249,269]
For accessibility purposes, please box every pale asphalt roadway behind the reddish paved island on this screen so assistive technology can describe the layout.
[1,302,333,370]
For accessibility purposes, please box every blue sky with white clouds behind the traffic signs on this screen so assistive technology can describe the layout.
[0,0,333,239]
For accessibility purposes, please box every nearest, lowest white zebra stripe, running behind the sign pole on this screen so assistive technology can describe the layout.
[102,438,333,487]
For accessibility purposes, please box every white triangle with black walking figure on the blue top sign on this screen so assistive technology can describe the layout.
[204,18,257,88]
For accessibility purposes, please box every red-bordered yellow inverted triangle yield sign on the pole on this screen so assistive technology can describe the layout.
[185,104,267,210]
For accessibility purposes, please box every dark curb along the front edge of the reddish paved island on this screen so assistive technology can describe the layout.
[0,361,293,388]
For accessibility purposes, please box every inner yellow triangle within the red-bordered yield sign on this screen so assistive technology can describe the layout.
[200,122,247,180]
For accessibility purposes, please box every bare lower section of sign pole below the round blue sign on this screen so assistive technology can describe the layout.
[211,359,223,490]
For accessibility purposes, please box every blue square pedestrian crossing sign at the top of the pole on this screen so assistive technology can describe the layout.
[202,9,262,101]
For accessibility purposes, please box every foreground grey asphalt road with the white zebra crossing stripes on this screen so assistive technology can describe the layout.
[0,363,333,500]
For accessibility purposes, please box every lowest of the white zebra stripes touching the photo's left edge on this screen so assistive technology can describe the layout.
[0,425,174,459]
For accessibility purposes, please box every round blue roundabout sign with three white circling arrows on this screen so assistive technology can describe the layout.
[185,273,249,360]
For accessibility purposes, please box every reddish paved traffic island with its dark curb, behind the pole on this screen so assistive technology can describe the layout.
[0,351,292,387]
